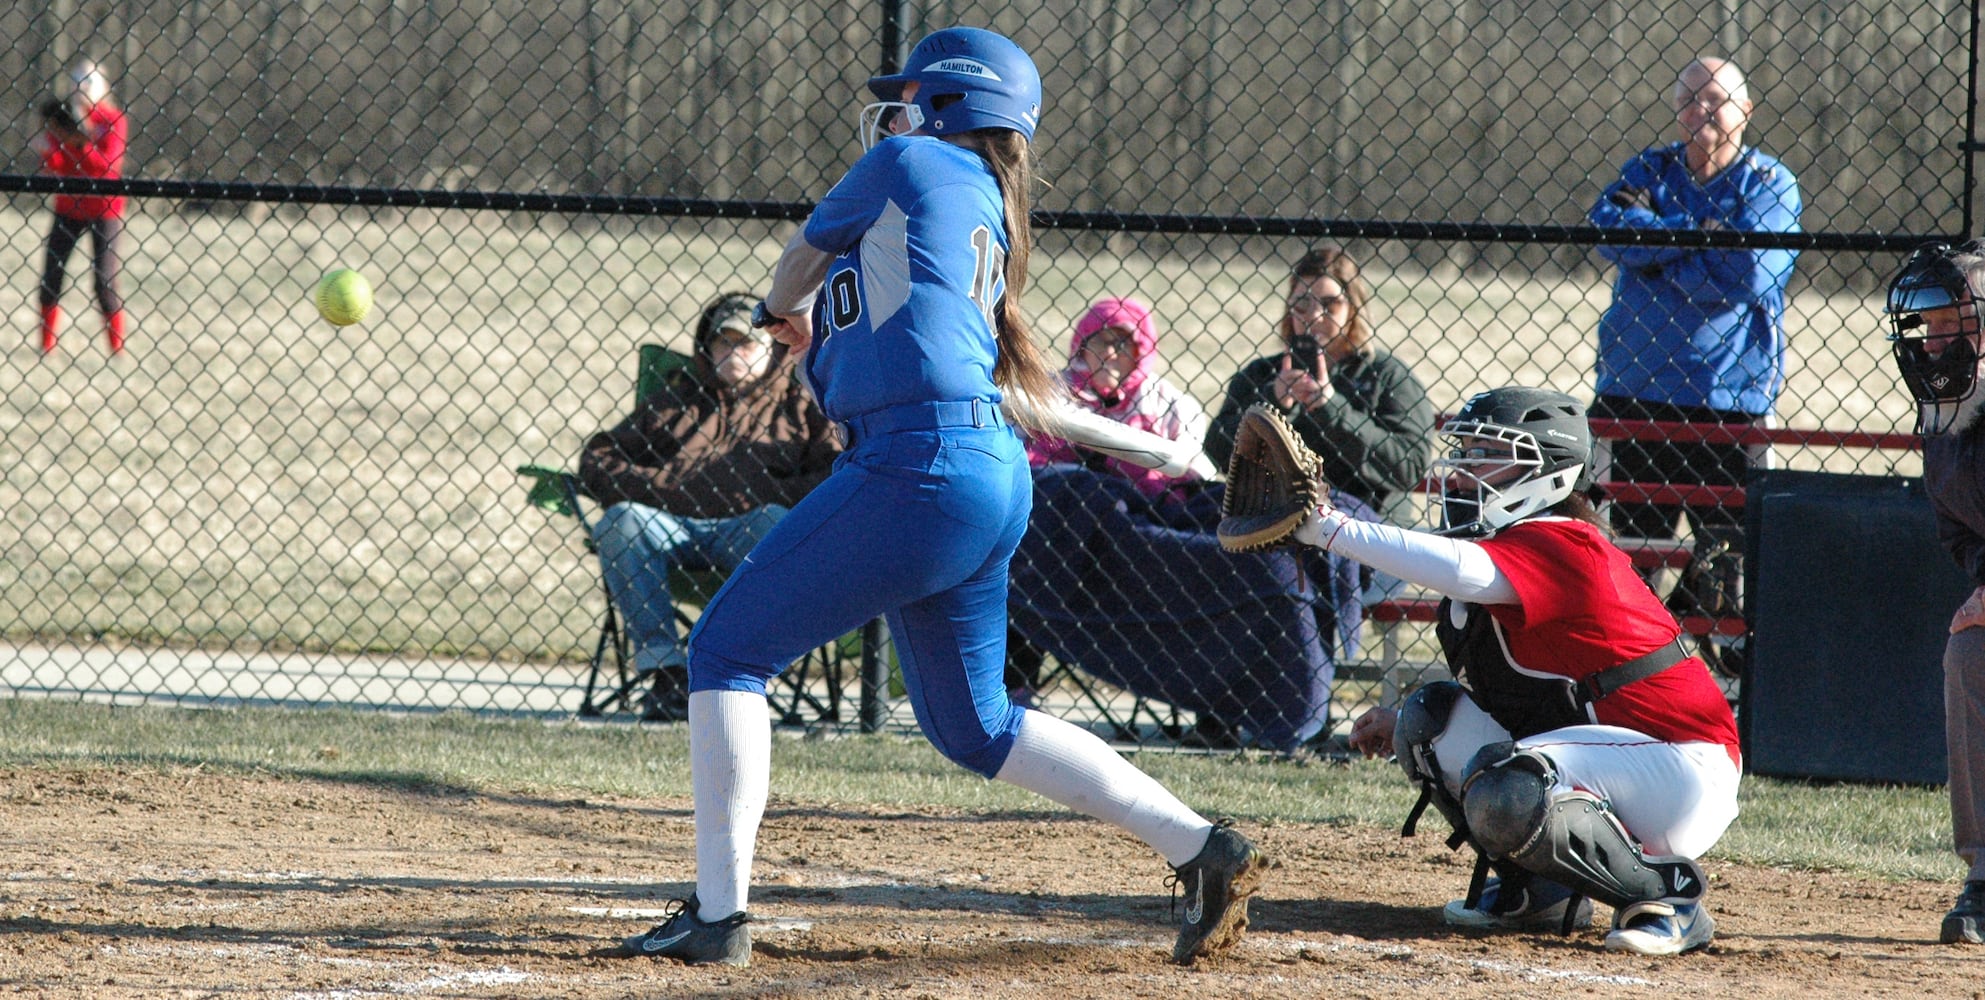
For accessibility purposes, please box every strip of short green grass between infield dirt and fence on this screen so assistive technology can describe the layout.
[0,700,1957,879]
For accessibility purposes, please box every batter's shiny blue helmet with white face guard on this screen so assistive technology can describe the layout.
[861,28,1040,147]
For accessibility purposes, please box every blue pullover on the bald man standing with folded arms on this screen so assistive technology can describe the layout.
[1590,143,1800,417]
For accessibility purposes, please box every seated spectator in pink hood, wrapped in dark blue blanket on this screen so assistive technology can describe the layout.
[1006,298,1364,750]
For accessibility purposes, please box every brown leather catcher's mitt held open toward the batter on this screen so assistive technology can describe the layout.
[1219,403,1324,552]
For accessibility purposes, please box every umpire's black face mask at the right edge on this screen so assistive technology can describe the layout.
[1882,240,1985,435]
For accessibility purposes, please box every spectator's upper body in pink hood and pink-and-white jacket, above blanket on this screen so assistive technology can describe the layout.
[1026,298,1207,502]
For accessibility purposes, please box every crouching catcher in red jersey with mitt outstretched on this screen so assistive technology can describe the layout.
[1219,387,1741,954]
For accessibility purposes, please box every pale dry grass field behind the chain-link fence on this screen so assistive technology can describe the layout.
[0,198,1914,674]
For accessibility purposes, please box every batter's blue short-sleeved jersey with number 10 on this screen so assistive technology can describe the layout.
[802,135,1008,421]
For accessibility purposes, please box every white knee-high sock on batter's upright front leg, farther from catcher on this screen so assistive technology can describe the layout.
[689,690,772,921]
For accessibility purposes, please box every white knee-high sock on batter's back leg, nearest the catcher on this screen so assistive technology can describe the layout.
[996,712,1213,867]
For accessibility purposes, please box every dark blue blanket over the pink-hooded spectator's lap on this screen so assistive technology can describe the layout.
[1008,466,1378,750]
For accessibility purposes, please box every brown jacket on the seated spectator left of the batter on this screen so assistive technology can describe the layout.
[580,351,840,518]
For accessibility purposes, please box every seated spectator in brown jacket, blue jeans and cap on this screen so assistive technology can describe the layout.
[580,294,840,720]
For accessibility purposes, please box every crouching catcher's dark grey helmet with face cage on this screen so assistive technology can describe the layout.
[1429,385,1592,536]
